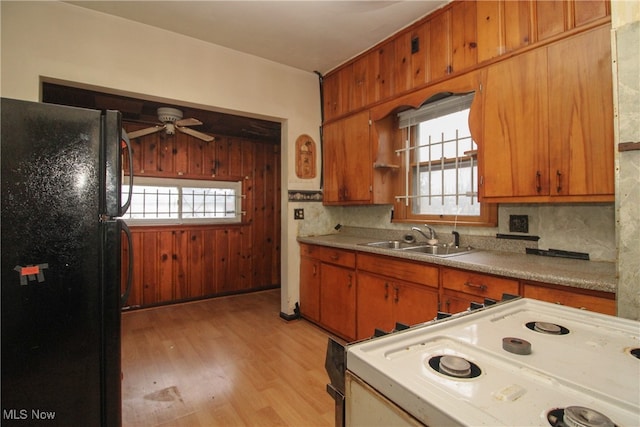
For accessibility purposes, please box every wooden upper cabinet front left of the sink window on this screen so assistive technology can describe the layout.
[323,111,373,205]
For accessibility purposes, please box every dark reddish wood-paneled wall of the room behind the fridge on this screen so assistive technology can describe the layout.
[122,123,281,307]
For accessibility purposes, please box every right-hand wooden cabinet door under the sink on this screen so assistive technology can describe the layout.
[392,282,438,326]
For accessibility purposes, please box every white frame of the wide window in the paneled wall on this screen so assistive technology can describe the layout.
[122,176,244,226]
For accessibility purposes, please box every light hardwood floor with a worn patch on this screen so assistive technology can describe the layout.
[122,289,334,427]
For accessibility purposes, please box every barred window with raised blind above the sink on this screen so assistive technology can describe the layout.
[396,93,496,227]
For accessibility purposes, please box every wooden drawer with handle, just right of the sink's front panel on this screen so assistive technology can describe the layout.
[441,268,519,300]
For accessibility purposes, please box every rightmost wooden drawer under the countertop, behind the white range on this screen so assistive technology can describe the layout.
[522,283,616,315]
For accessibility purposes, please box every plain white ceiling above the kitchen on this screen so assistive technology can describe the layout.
[69,0,449,74]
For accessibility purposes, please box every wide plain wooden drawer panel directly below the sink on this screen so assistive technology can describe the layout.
[358,253,439,288]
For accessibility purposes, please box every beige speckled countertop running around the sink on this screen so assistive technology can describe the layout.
[298,234,618,293]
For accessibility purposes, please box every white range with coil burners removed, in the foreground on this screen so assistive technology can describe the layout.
[345,298,640,427]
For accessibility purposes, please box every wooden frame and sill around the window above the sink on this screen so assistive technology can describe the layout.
[393,92,498,227]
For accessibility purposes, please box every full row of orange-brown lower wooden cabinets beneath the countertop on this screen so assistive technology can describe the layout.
[300,244,616,341]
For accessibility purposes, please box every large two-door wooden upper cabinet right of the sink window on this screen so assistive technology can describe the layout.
[479,27,614,202]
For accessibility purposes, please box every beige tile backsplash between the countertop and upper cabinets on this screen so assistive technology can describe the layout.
[290,203,616,261]
